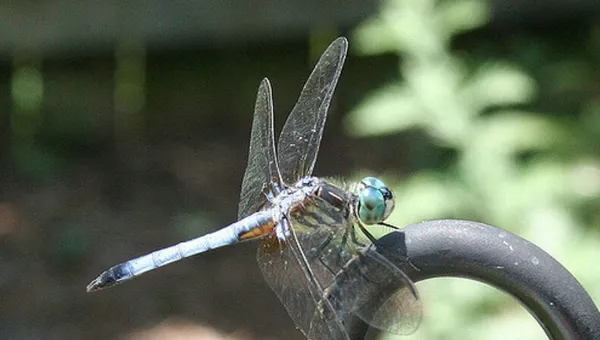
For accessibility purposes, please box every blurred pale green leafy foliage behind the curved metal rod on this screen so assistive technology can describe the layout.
[346,0,600,339]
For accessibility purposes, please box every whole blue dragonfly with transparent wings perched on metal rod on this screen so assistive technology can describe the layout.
[87,37,422,340]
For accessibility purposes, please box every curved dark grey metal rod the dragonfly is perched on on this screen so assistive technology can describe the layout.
[348,220,600,340]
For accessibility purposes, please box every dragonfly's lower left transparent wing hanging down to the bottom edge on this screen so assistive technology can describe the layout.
[258,194,349,340]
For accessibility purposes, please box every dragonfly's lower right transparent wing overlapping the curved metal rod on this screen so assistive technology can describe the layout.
[326,244,422,335]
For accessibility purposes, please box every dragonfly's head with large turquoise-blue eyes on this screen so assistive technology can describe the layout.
[356,177,394,225]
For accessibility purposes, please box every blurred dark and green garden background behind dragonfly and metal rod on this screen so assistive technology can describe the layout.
[0,0,600,339]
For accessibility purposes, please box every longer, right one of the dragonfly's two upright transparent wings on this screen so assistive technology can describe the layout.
[277,37,348,183]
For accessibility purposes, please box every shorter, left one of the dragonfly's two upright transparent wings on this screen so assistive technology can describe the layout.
[238,78,281,219]
